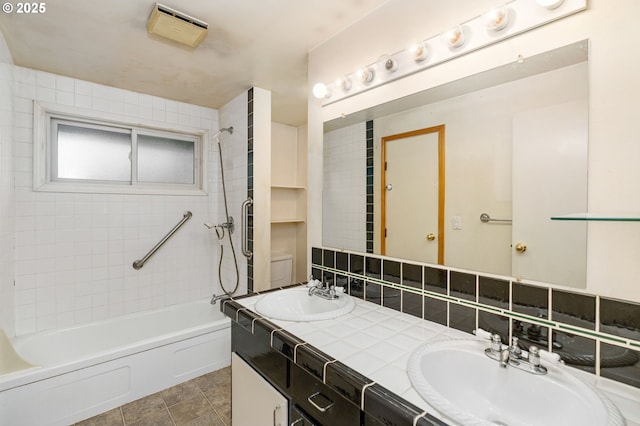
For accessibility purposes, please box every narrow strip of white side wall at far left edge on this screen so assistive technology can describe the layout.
[0,33,15,336]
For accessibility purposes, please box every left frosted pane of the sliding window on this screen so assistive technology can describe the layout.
[51,122,131,182]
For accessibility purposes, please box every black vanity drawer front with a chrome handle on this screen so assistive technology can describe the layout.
[291,364,360,426]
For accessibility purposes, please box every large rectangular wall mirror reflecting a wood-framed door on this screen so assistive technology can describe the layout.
[323,41,588,288]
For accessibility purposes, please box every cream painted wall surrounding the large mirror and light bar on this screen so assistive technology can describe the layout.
[308,0,640,301]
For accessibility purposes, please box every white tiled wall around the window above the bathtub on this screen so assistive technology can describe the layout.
[9,67,225,335]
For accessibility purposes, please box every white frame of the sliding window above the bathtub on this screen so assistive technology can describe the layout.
[33,101,209,195]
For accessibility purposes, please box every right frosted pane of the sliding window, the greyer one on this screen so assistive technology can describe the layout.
[137,134,195,184]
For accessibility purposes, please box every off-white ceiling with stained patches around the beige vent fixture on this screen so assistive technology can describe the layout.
[0,0,387,126]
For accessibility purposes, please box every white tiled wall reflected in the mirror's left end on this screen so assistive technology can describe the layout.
[322,122,367,252]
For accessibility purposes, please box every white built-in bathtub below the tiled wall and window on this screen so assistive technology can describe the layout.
[0,299,231,426]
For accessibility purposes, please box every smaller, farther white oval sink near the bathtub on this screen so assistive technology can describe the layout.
[254,287,356,321]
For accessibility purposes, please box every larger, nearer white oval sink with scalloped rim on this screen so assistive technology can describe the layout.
[407,340,625,426]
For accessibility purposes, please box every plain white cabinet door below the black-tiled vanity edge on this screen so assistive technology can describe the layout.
[231,353,289,426]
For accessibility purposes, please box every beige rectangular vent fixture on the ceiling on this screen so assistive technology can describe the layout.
[147,3,209,47]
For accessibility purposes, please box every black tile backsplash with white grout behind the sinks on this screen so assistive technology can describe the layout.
[311,247,640,388]
